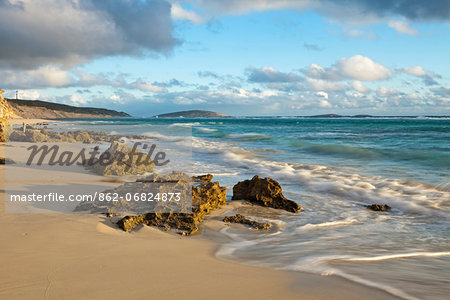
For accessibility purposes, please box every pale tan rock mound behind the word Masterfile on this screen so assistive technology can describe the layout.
[92,141,154,176]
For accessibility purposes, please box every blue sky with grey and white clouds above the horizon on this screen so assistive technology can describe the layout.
[0,0,450,117]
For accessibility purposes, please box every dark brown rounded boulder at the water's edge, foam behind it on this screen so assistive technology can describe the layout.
[232,175,301,213]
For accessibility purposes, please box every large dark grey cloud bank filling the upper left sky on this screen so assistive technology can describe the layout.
[0,0,179,69]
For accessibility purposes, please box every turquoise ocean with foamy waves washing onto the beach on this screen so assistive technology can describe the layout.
[50,117,450,299]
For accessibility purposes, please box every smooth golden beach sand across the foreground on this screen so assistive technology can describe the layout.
[0,141,395,299]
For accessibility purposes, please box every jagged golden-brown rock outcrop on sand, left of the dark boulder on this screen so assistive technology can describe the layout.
[112,173,226,235]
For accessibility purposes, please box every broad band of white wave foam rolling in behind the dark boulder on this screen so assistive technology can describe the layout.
[193,139,450,217]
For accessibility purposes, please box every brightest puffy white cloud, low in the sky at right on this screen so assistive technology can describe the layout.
[336,55,392,80]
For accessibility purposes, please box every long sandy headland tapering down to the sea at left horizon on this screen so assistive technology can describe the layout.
[6,99,131,119]
